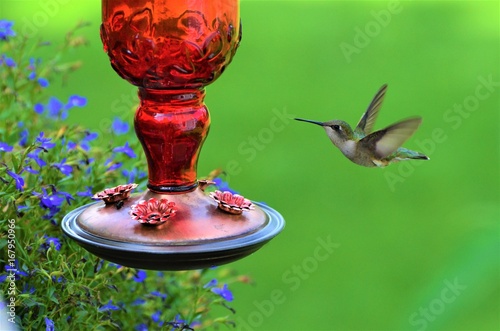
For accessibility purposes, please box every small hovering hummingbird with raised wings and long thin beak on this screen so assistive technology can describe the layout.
[295,84,429,167]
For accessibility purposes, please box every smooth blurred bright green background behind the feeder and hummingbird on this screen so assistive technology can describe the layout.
[0,0,500,331]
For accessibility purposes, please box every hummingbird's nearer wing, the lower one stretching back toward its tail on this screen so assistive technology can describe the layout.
[359,117,422,159]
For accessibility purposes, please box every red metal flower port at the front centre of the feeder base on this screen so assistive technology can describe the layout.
[130,198,176,225]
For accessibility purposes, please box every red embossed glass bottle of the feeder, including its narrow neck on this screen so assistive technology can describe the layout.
[101,0,241,192]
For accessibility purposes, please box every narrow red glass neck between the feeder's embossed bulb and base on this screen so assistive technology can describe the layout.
[134,88,210,192]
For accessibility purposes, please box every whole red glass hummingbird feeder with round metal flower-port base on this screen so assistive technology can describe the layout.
[62,0,284,270]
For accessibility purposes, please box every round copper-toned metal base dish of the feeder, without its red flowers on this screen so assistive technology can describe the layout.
[61,188,285,270]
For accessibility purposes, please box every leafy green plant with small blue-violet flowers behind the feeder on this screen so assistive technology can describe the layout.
[0,20,249,331]
